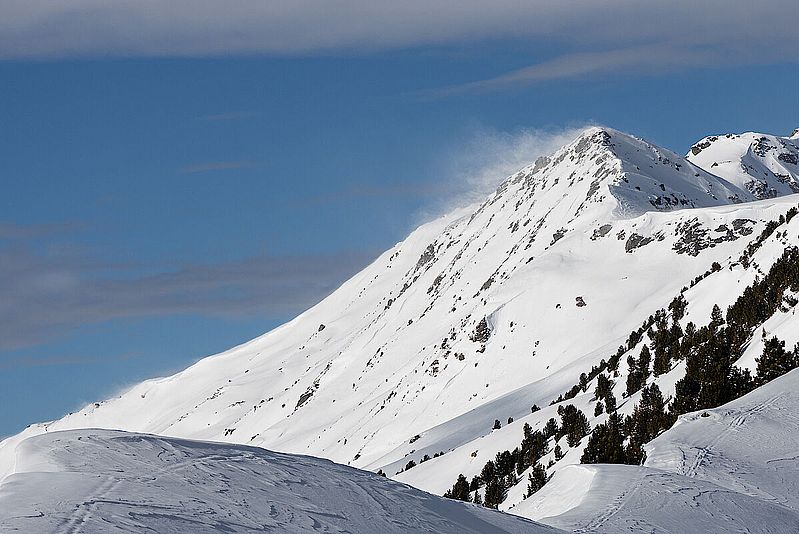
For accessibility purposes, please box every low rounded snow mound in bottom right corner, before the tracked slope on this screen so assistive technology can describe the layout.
[512,464,799,534]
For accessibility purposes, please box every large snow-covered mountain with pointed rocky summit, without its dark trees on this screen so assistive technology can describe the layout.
[0,128,799,532]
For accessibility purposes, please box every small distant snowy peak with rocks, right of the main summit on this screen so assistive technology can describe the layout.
[687,129,799,198]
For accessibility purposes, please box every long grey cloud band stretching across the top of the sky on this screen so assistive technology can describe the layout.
[0,0,799,89]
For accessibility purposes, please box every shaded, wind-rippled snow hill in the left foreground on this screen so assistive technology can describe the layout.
[0,430,555,534]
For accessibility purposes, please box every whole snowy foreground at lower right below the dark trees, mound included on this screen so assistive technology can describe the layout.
[514,370,799,533]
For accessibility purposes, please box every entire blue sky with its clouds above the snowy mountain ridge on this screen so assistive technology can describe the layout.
[0,0,799,435]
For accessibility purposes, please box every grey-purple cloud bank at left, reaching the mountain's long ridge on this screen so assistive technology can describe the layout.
[0,228,376,350]
